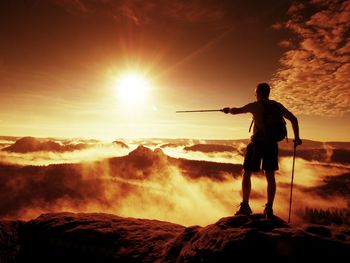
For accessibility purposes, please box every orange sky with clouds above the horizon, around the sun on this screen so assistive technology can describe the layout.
[0,0,350,141]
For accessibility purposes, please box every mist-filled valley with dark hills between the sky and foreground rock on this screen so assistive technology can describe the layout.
[0,137,350,226]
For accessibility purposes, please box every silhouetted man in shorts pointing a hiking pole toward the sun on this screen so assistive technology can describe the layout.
[222,83,302,218]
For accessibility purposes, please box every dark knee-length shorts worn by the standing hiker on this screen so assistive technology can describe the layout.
[243,141,278,172]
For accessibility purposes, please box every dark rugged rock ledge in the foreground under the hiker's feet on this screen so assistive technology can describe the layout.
[0,213,350,263]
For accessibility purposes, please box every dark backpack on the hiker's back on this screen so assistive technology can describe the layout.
[249,100,287,142]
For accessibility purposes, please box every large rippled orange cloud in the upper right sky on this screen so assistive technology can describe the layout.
[271,1,350,116]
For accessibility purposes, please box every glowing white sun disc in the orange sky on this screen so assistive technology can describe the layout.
[117,73,149,107]
